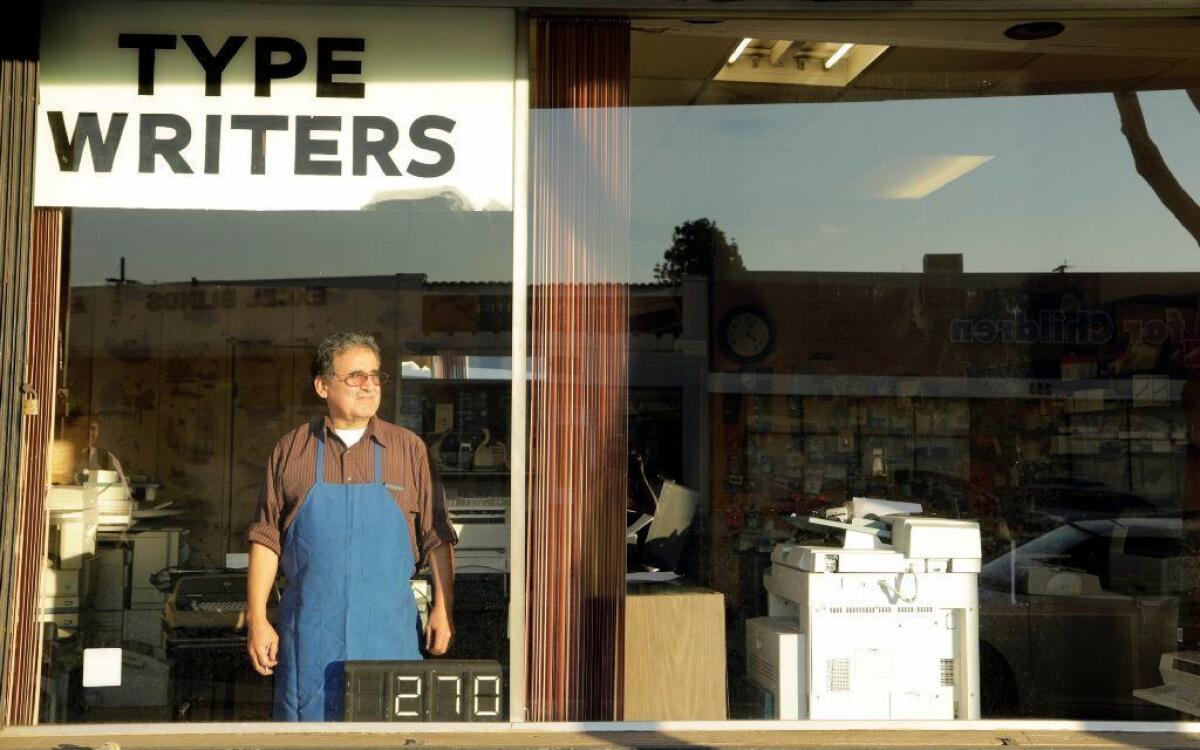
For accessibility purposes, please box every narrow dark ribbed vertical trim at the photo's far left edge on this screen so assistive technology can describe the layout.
[0,2,40,725]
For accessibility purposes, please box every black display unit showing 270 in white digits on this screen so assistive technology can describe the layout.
[346,659,505,721]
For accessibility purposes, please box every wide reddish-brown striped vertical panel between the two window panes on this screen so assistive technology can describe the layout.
[527,18,630,721]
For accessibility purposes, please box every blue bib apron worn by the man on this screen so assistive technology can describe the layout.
[275,428,421,721]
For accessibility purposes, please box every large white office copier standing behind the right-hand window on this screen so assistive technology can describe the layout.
[746,498,982,720]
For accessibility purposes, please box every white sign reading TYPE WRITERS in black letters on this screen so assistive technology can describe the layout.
[35,0,515,210]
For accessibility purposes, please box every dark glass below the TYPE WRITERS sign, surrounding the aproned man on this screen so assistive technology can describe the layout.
[42,206,512,722]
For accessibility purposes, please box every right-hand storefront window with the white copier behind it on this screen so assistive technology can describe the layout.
[625,19,1200,720]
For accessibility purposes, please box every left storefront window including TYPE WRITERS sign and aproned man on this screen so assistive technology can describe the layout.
[37,4,521,724]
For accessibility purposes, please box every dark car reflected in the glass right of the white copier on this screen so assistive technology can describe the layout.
[979,516,1198,720]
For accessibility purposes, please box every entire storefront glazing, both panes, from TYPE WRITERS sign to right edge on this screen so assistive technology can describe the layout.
[25,2,1200,726]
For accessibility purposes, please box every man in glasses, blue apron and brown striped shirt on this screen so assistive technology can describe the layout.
[246,332,457,721]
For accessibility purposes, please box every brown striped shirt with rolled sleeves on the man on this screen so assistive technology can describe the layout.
[246,416,458,568]
